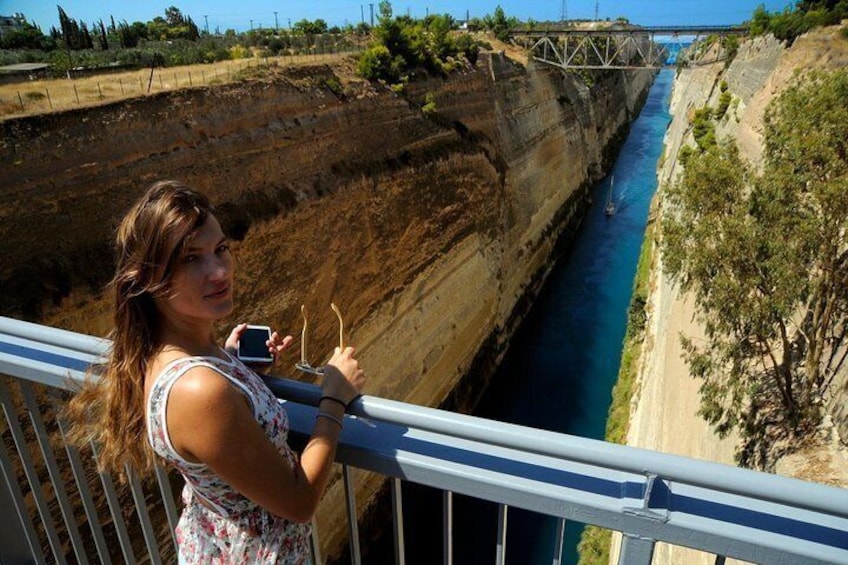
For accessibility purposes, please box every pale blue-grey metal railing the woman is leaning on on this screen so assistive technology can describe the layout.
[0,318,848,565]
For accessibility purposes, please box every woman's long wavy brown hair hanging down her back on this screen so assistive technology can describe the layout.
[66,181,213,479]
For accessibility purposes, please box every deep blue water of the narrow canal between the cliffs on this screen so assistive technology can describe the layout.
[404,70,674,564]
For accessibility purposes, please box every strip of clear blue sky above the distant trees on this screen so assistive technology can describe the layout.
[0,0,795,33]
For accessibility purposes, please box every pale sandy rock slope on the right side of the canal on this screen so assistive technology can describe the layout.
[628,28,848,564]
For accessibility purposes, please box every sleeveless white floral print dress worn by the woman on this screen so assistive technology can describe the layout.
[147,356,311,565]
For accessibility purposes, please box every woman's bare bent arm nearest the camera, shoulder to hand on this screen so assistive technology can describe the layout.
[167,348,365,522]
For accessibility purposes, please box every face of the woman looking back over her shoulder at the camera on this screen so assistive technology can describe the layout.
[159,214,233,322]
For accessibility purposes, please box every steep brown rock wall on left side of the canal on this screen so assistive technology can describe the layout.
[0,53,652,555]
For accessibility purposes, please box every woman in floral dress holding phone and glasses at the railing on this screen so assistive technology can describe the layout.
[70,181,365,563]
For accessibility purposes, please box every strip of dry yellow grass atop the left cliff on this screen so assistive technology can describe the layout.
[0,53,350,120]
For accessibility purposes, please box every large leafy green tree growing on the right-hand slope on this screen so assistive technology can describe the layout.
[662,70,848,467]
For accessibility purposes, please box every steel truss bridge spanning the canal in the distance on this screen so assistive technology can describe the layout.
[509,26,748,69]
